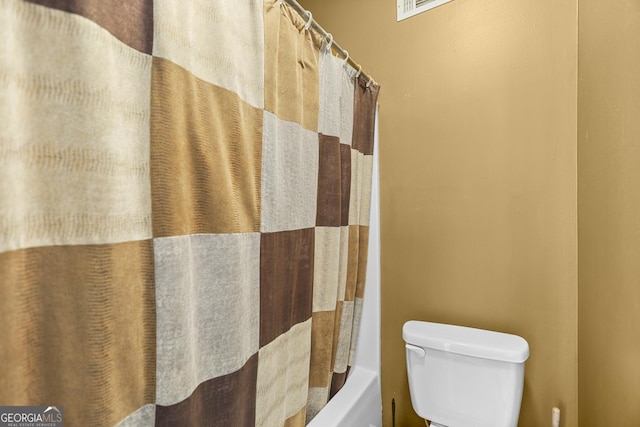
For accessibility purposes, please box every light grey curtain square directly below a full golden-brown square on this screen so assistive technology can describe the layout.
[154,233,260,406]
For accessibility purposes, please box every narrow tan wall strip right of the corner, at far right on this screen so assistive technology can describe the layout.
[578,0,640,427]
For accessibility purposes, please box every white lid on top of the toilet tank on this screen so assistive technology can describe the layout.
[402,320,529,363]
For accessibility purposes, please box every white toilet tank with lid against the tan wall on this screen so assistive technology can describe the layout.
[402,320,529,427]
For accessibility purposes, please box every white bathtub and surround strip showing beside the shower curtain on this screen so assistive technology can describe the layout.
[307,114,382,427]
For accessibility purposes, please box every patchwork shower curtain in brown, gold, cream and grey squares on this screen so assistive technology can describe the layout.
[0,0,378,427]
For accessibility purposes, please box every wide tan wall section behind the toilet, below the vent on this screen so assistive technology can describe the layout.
[301,0,578,427]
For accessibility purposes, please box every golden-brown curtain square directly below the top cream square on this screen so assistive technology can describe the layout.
[151,58,262,237]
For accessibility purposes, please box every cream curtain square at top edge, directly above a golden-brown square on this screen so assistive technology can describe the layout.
[153,0,267,108]
